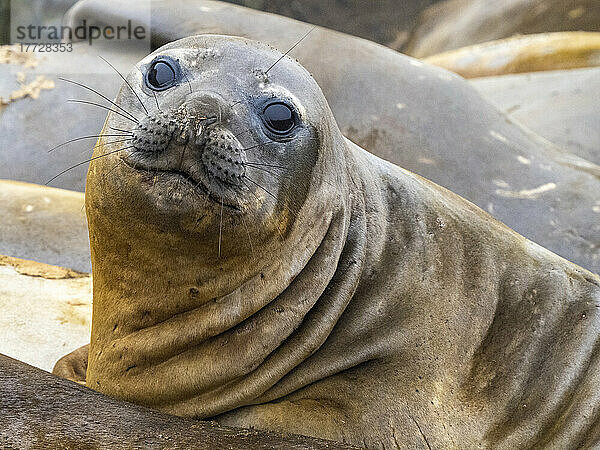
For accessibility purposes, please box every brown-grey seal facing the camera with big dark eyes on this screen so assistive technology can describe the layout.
[57,35,600,448]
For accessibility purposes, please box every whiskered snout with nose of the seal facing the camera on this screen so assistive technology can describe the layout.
[126,86,247,206]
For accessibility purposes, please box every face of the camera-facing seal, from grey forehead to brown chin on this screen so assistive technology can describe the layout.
[88,36,340,253]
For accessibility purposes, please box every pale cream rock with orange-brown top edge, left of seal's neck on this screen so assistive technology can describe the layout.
[0,256,92,370]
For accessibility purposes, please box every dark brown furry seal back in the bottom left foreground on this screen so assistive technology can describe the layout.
[0,354,342,450]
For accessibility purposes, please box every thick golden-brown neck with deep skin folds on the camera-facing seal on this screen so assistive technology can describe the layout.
[87,168,365,417]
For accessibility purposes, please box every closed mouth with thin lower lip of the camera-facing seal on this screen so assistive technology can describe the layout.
[121,157,241,212]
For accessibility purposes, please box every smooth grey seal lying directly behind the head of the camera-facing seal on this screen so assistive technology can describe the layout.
[65,0,600,272]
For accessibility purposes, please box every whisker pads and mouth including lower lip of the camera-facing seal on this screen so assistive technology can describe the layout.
[115,103,247,210]
